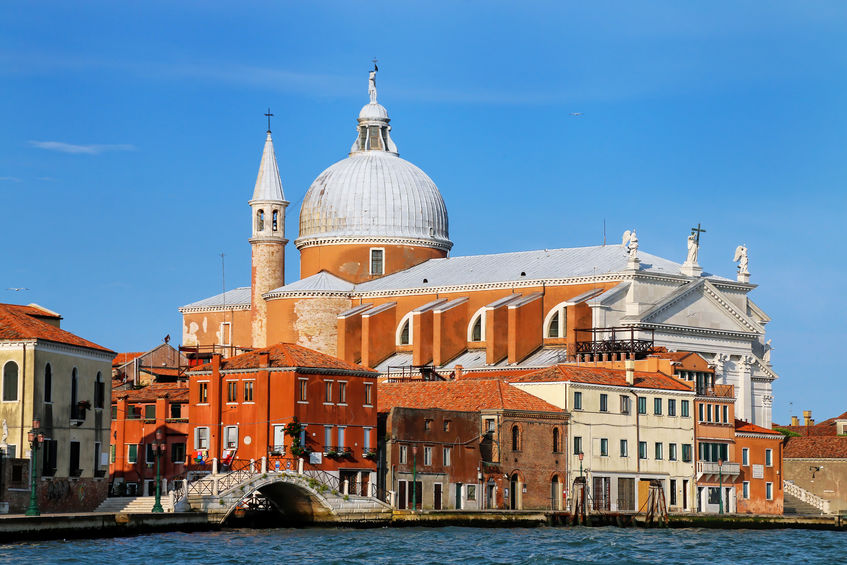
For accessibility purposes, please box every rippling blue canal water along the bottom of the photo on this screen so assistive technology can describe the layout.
[0,527,847,565]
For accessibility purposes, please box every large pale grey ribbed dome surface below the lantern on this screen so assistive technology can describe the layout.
[295,151,453,249]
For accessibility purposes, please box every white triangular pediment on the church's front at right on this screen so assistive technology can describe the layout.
[638,279,765,334]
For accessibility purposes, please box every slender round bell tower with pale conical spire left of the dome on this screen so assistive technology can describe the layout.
[249,115,288,347]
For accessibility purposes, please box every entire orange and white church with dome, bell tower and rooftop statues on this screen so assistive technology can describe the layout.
[180,71,777,427]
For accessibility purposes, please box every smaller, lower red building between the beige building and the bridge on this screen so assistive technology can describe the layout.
[109,383,188,496]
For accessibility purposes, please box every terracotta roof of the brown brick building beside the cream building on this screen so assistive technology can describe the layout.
[377,379,562,412]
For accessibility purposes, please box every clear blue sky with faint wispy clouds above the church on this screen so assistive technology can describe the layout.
[0,1,847,421]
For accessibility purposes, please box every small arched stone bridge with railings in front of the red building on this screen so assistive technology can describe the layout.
[181,461,392,523]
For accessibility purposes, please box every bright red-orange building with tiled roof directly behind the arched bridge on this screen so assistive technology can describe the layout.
[192,343,378,494]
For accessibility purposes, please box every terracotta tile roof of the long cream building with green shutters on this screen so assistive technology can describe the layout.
[507,365,692,392]
